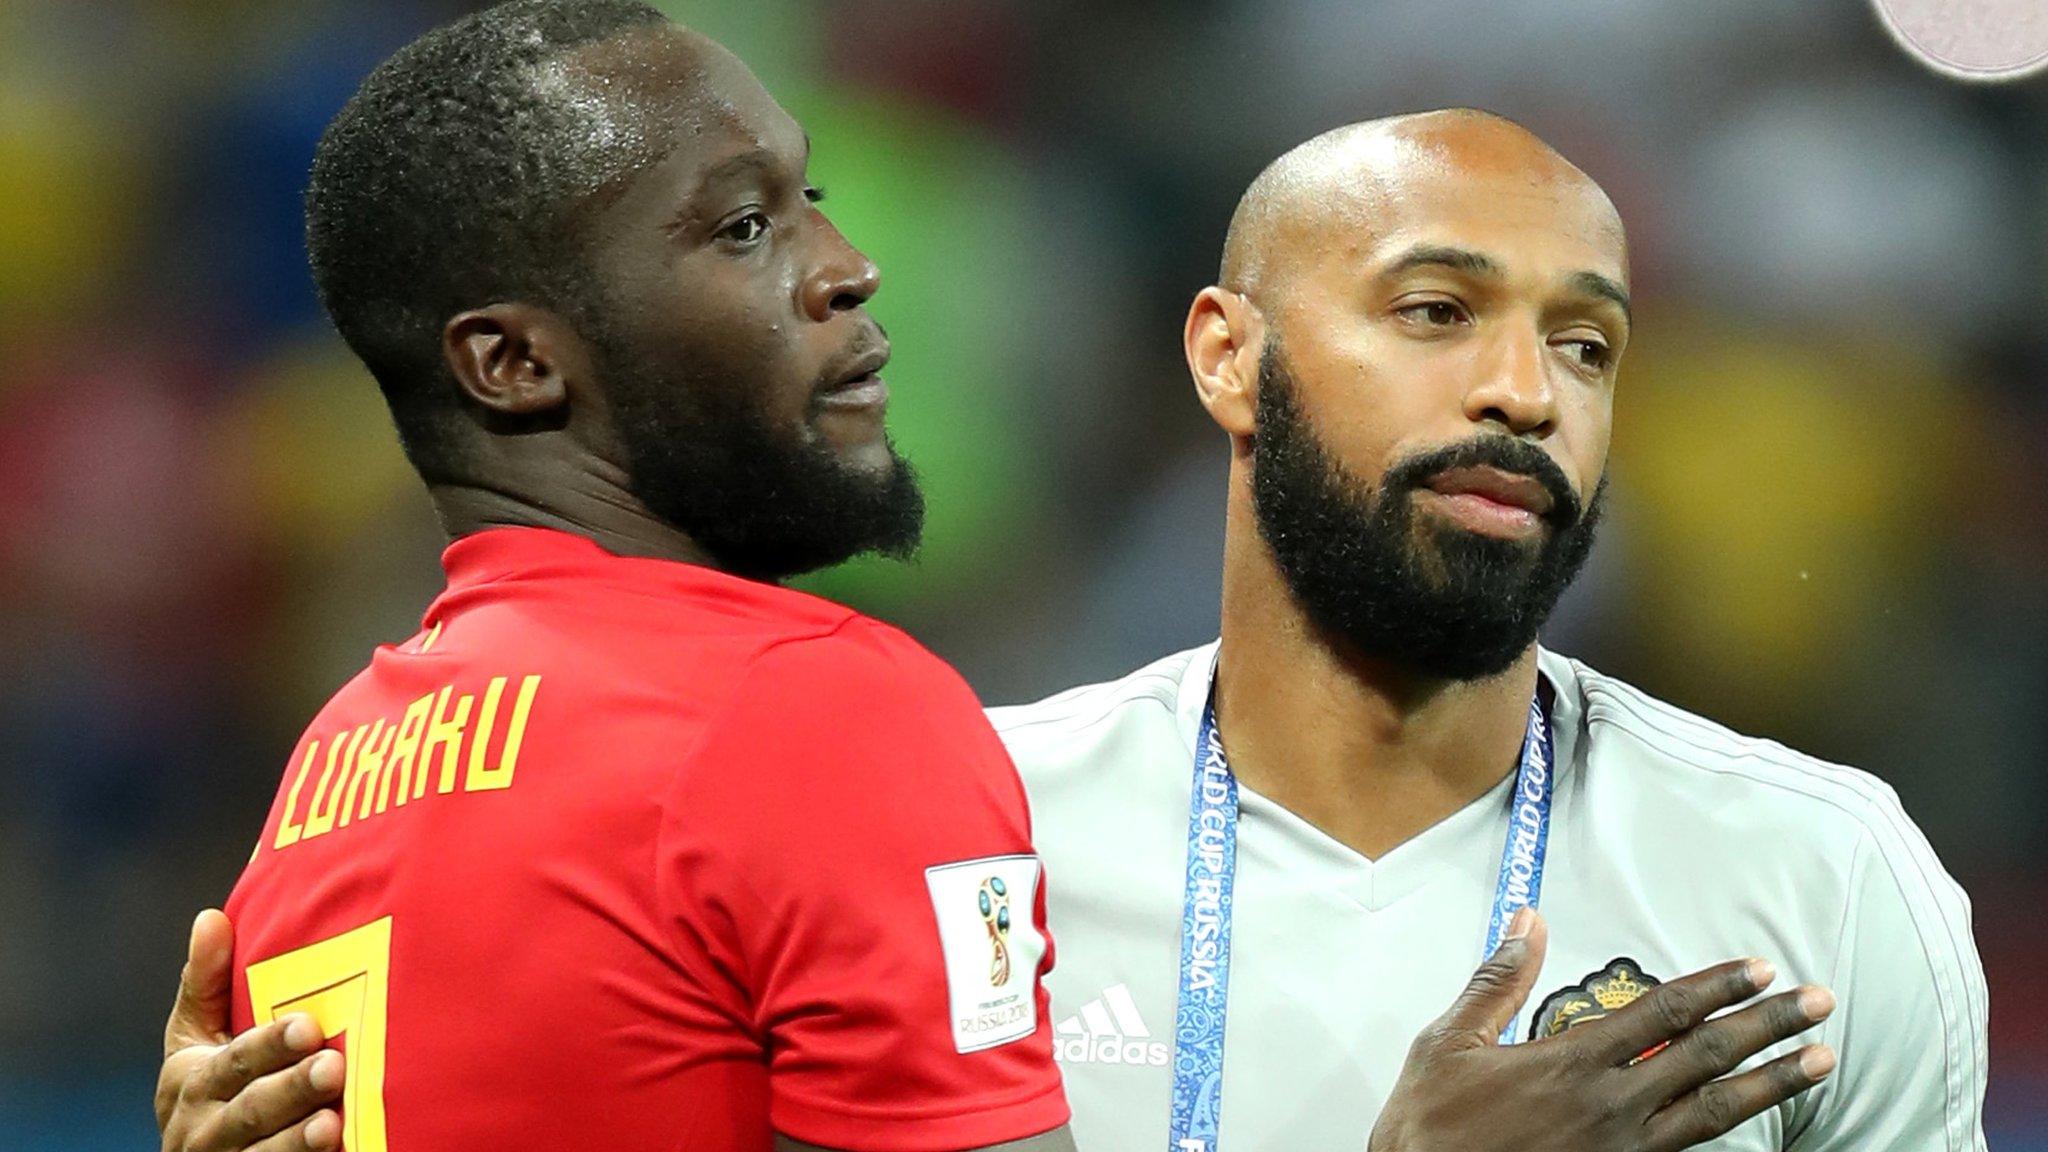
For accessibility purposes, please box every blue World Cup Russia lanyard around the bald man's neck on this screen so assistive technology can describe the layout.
[1167,695,1554,1152]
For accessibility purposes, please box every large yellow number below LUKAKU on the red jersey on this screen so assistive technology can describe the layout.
[248,916,391,1152]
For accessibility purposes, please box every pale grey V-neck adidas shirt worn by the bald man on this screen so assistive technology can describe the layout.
[989,644,1987,1152]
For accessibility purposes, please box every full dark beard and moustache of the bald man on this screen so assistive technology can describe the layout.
[1251,346,1608,681]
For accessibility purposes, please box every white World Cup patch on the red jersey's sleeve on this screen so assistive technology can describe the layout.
[924,855,1044,1052]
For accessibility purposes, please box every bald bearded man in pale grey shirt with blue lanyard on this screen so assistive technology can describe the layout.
[160,47,1985,1152]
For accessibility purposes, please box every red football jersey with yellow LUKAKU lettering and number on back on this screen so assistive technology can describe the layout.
[227,529,1067,1152]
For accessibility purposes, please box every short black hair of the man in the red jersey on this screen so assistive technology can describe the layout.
[305,0,668,482]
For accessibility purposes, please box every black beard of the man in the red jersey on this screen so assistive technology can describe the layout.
[592,330,924,580]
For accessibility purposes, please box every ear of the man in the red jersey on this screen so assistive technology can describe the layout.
[440,303,590,416]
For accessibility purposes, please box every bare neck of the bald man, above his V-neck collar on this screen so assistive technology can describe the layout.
[1217,463,1536,859]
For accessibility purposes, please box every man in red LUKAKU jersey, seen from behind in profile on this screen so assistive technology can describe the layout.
[149,0,1071,1152]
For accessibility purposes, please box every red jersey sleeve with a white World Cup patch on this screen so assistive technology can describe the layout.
[655,619,1067,1152]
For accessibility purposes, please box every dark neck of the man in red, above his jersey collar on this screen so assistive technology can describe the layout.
[426,459,721,568]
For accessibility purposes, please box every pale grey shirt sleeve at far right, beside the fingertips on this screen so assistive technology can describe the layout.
[1788,819,1989,1152]
